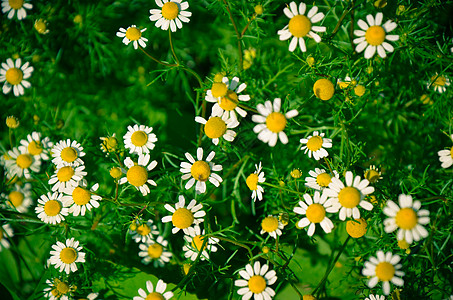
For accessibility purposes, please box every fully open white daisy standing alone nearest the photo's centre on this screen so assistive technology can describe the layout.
[179,148,222,194]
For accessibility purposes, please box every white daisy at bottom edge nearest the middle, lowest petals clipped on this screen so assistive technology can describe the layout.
[234,261,277,300]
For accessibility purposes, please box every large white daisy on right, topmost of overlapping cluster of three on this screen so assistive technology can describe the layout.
[323,171,374,221]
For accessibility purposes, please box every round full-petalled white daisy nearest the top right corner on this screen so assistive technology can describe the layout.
[353,12,399,59]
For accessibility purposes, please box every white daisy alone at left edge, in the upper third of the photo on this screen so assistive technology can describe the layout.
[0,58,33,97]
